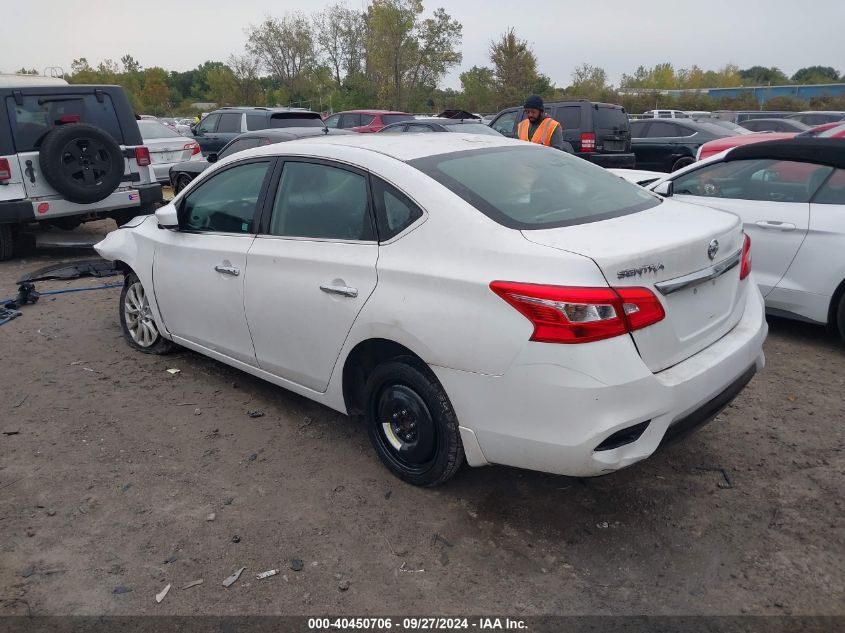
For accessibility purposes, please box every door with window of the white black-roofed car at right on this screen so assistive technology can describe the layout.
[673,159,831,296]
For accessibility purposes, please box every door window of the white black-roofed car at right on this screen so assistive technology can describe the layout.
[673,159,833,202]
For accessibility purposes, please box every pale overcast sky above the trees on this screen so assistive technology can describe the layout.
[0,0,845,88]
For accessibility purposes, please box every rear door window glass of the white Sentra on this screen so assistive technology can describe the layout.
[270,161,375,241]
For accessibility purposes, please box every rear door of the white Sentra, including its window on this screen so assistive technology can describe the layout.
[244,159,379,391]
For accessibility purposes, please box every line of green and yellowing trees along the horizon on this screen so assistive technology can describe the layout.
[11,0,845,115]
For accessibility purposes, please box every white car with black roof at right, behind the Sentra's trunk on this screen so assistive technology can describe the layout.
[648,138,845,338]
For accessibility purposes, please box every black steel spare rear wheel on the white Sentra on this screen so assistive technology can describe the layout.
[365,357,464,486]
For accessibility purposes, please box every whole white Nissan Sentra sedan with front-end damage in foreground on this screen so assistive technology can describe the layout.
[96,134,767,485]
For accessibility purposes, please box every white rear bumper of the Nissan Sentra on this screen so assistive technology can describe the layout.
[432,286,768,476]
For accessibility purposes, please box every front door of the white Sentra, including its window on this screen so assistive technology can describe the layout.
[153,159,274,366]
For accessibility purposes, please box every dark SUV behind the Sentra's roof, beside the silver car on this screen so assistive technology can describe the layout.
[191,107,325,156]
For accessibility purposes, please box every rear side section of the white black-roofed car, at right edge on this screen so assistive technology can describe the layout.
[767,169,845,323]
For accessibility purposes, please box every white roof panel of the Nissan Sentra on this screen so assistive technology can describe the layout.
[234,133,516,162]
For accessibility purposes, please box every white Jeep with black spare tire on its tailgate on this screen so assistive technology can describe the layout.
[0,81,162,260]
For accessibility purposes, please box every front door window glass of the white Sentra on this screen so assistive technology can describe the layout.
[179,161,270,233]
